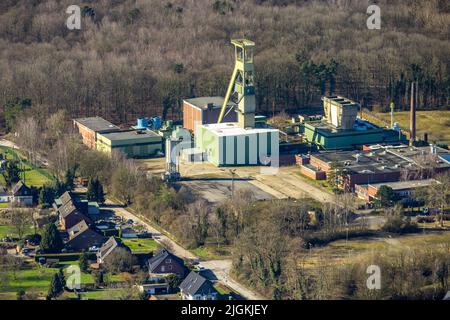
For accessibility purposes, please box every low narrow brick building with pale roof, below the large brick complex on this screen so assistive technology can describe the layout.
[355,179,439,202]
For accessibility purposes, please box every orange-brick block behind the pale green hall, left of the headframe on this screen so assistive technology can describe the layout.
[183,97,237,133]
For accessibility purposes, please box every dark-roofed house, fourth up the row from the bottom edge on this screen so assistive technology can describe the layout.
[66,220,105,251]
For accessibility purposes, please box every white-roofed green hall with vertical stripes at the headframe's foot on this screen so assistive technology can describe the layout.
[195,123,279,166]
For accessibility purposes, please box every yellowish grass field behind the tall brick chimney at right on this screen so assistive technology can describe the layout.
[368,110,450,144]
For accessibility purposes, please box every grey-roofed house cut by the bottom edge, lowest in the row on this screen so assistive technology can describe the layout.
[180,271,218,300]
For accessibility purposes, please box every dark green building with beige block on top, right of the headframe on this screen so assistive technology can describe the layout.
[303,96,406,150]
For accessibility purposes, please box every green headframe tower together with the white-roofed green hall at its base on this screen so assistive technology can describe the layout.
[192,39,279,166]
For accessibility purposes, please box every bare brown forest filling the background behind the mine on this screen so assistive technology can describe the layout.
[0,0,450,129]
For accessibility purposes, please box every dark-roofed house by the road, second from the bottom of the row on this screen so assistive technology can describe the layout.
[148,249,187,280]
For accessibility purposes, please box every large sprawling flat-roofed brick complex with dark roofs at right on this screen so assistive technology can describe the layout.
[297,145,450,191]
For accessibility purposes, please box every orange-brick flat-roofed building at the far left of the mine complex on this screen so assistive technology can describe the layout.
[73,117,120,149]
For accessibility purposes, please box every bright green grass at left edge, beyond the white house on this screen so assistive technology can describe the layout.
[0,146,54,187]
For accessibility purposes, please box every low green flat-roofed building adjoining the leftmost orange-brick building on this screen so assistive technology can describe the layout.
[97,130,163,158]
